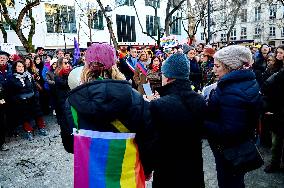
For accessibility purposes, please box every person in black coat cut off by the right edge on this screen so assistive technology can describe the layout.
[262,45,284,173]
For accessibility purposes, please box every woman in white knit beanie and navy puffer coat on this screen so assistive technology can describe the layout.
[205,45,261,188]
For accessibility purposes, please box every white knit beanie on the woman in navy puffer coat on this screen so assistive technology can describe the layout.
[213,45,252,70]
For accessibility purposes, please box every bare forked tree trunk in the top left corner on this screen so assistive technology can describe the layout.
[0,0,40,52]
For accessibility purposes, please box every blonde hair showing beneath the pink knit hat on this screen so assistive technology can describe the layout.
[81,62,126,84]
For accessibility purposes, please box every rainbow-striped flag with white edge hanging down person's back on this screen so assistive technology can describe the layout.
[73,129,145,188]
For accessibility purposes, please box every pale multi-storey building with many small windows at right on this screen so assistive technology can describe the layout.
[197,0,284,46]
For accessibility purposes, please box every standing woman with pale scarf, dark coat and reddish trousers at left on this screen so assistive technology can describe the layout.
[7,61,47,140]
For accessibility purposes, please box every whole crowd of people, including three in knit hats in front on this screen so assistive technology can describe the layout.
[0,43,284,188]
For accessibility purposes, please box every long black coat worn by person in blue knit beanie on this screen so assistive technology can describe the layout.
[150,80,206,188]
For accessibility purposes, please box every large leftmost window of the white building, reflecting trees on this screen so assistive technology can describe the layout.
[45,3,77,33]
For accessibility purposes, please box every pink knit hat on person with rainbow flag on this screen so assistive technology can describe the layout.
[86,43,116,69]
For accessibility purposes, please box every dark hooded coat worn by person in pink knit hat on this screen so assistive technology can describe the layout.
[61,80,155,174]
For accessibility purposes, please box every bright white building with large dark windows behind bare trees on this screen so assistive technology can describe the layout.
[0,0,187,49]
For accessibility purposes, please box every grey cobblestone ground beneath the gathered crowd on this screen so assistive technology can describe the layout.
[0,116,284,188]
